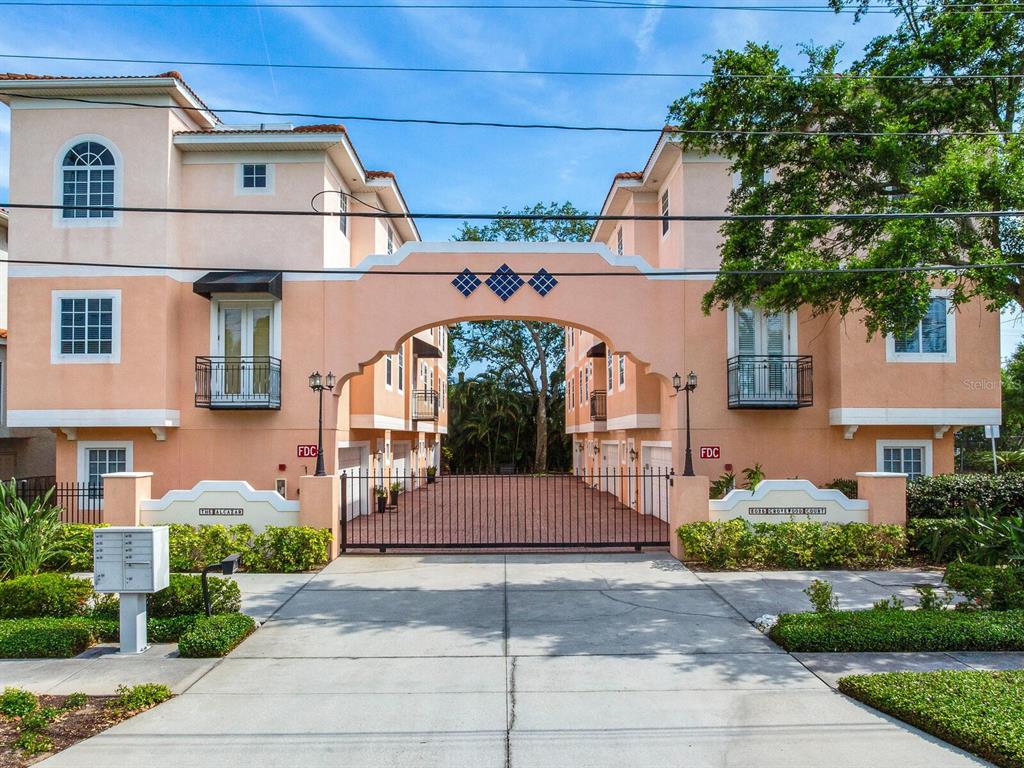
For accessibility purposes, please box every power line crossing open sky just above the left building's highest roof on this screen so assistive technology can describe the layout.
[0,53,1024,83]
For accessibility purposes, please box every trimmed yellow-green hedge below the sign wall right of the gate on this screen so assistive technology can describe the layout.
[676,518,906,569]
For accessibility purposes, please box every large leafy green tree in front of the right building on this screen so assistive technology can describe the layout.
[670,0,1024,333]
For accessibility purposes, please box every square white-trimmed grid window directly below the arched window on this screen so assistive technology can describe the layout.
[50,290,121,365]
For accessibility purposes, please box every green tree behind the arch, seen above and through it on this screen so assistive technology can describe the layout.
[451,203,593,471]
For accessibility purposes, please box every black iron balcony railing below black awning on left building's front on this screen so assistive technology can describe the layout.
[196,356,281,411]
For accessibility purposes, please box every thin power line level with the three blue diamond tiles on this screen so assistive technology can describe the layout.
[0,253,1024,279]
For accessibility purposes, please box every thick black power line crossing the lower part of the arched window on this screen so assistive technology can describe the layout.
[6,202,1024,222]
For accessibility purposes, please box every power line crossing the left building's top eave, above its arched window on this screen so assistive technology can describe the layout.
[0,91,1024,140]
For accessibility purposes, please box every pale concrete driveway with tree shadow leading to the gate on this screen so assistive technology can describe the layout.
[45,554,984,768]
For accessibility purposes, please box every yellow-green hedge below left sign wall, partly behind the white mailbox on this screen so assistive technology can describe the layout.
[49,523,331,573]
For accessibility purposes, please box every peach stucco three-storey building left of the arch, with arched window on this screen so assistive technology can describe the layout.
[0,73,447,507]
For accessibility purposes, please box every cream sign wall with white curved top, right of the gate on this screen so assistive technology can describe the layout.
[709,480,869,522]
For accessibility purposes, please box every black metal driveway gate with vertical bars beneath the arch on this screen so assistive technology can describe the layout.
[340,470,673,552]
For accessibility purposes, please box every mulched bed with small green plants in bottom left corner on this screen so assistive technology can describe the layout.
[0,684,171,768]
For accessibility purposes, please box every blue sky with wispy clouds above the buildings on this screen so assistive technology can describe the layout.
[0,0,1024,356]
